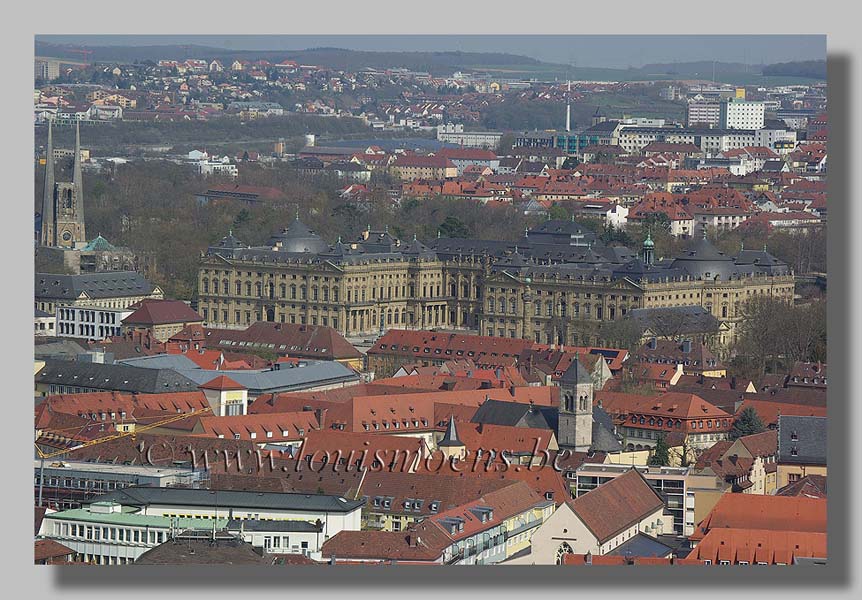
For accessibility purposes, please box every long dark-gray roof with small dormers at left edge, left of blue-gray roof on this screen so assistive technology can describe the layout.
[35,359,199,394]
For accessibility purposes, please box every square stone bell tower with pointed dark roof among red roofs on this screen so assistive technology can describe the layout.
[557,356,594,452]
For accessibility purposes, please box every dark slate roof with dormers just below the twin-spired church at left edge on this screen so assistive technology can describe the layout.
[35,271,156,300]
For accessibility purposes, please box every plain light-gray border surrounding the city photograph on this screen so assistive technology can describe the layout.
[5,0,862,599]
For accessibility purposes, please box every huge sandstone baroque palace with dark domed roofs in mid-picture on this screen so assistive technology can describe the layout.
[198,218,794,346]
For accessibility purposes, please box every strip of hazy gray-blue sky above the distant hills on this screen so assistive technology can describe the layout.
[36,35,826,68]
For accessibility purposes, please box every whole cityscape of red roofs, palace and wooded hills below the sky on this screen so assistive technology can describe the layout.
[32,36,837,568]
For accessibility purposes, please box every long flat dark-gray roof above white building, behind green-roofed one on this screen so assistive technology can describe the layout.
[93,486,365,513]
